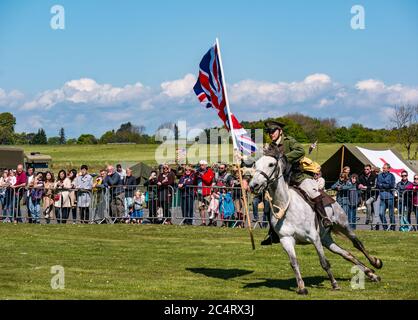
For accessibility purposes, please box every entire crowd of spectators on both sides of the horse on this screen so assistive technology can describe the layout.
[0,160,418,230]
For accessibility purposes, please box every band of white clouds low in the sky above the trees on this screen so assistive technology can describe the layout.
[8,73,418,136]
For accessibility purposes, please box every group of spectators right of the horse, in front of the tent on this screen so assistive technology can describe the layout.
[331,163,418,231]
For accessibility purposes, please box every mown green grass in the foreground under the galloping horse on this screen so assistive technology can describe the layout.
[0,225,418,300]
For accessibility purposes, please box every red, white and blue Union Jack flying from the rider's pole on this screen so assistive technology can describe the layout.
[193,44,257,154]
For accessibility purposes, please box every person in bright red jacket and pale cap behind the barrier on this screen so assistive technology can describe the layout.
[196,160,215,226]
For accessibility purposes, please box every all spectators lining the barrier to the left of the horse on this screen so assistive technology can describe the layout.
[0,160,249,226]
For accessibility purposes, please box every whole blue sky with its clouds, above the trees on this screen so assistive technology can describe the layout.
[0,0,418,136]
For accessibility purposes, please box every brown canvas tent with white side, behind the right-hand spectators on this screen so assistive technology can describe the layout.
[321,144,415,187]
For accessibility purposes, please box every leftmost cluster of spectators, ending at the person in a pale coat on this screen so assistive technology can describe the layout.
[0,165,94,224]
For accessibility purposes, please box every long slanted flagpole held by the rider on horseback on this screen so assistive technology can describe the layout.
[216,38,255,250]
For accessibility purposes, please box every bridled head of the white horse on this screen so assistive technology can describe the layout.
[249,145,283,194]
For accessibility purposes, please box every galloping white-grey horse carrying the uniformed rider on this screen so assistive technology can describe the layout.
[250,150,383,294]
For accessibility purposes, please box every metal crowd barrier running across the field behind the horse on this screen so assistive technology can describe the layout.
[0,185,418,231]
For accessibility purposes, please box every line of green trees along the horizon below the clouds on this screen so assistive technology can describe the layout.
[0,105,418,159]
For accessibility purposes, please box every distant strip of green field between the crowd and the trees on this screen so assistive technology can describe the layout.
[19,143,415,172]
